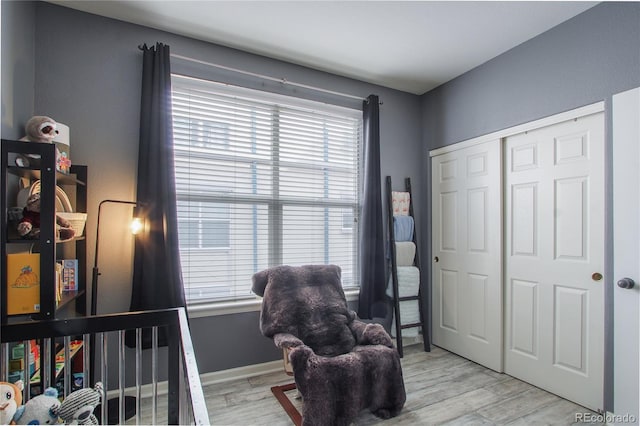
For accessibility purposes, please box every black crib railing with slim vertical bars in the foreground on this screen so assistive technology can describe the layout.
[0,308,209,425]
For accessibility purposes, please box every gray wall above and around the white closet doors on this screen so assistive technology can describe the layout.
[422,2,640,409]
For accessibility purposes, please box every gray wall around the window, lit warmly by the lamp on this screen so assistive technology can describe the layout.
[2,1,422,373]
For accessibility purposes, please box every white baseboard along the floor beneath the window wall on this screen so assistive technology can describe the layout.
[107,360,284,399]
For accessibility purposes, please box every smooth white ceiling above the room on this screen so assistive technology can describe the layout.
[51,0,597,94]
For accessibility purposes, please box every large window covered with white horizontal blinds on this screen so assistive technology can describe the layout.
[172,75,362,303]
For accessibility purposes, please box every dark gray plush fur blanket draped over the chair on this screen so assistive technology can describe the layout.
[252,265,406,425]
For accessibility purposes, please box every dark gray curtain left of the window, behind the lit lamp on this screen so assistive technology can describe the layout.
[127,43,185,347]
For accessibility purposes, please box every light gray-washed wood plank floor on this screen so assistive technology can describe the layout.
[138,345,603,426]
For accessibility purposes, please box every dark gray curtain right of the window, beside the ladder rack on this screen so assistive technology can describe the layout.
[358,95,387,319]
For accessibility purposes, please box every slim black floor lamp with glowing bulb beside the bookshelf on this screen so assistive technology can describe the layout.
[90,200,142,424]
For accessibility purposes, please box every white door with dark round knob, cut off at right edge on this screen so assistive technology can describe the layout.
[613,88,640,424]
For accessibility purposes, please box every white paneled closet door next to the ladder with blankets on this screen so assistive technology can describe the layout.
[432,140,503,371]
